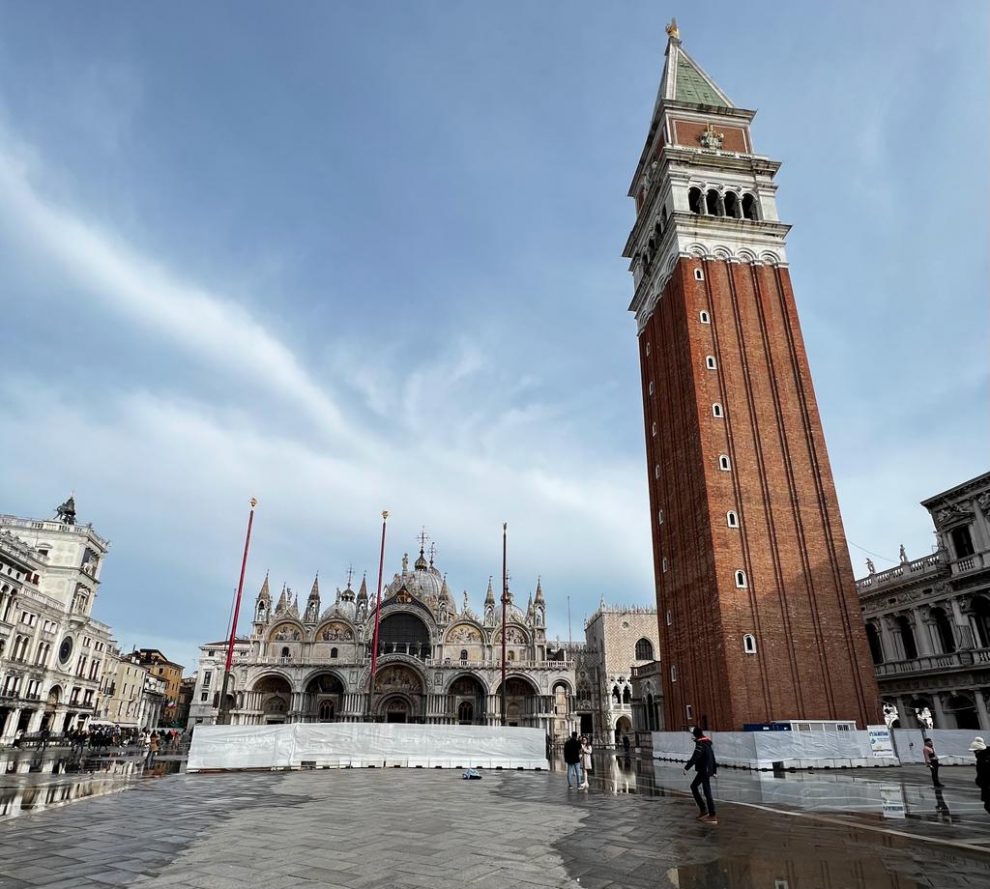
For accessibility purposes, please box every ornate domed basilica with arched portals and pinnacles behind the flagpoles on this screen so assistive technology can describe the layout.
[190,547,575,737]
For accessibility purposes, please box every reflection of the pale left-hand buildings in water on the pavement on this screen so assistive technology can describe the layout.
[0,749,185,821]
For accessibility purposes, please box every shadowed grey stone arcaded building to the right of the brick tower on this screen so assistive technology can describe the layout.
[856,473,990,731]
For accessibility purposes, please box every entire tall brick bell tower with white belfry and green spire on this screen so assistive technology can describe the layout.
[624,22,882,730]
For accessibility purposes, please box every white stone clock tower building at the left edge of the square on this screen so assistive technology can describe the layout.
[0,498,113,744]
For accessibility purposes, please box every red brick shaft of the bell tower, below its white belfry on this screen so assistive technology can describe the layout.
[640,259,880,730]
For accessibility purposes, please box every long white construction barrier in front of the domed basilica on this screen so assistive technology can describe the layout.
[187,722,549,772]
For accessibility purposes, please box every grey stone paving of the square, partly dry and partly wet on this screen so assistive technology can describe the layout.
[0,758,990,889]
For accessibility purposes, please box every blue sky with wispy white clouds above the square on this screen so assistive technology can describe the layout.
[0,0,990,672]
